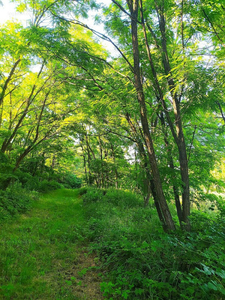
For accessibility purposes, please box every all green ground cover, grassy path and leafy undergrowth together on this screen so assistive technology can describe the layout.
[0,187,225,300]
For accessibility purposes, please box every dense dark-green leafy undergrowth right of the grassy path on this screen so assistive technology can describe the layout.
[80,188,225,300]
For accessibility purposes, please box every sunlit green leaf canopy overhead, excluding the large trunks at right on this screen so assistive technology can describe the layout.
[0,0,224,221]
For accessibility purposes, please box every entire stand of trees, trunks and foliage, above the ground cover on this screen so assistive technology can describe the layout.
[0,0,225,231]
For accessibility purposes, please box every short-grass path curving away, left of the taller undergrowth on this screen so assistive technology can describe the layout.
[0,190,102,300]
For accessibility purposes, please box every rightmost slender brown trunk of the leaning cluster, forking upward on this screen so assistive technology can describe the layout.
[140,0,190,230]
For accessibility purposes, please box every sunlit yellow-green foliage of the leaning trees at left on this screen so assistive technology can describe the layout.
[0,20,83,173]
